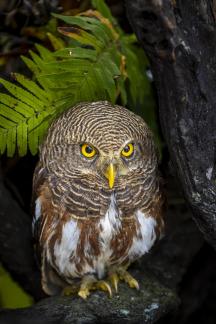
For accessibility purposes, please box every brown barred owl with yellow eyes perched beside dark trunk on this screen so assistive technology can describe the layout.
[33,101,164,299]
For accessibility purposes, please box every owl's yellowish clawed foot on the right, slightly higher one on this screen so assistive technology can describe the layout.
[109,268,139,292]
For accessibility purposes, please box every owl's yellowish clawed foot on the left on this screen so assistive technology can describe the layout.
[78,276,112,299]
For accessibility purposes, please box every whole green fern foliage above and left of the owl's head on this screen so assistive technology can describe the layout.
[0,0,151,156]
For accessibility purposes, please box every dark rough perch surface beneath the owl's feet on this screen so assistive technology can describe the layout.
[0,269,179,324]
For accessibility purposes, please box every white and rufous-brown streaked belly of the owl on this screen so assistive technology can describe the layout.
[50,197,156,280]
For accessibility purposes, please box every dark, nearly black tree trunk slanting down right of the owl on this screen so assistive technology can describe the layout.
[126,0,216,248]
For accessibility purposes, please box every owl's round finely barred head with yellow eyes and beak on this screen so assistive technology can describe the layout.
[41,101,157,189]
